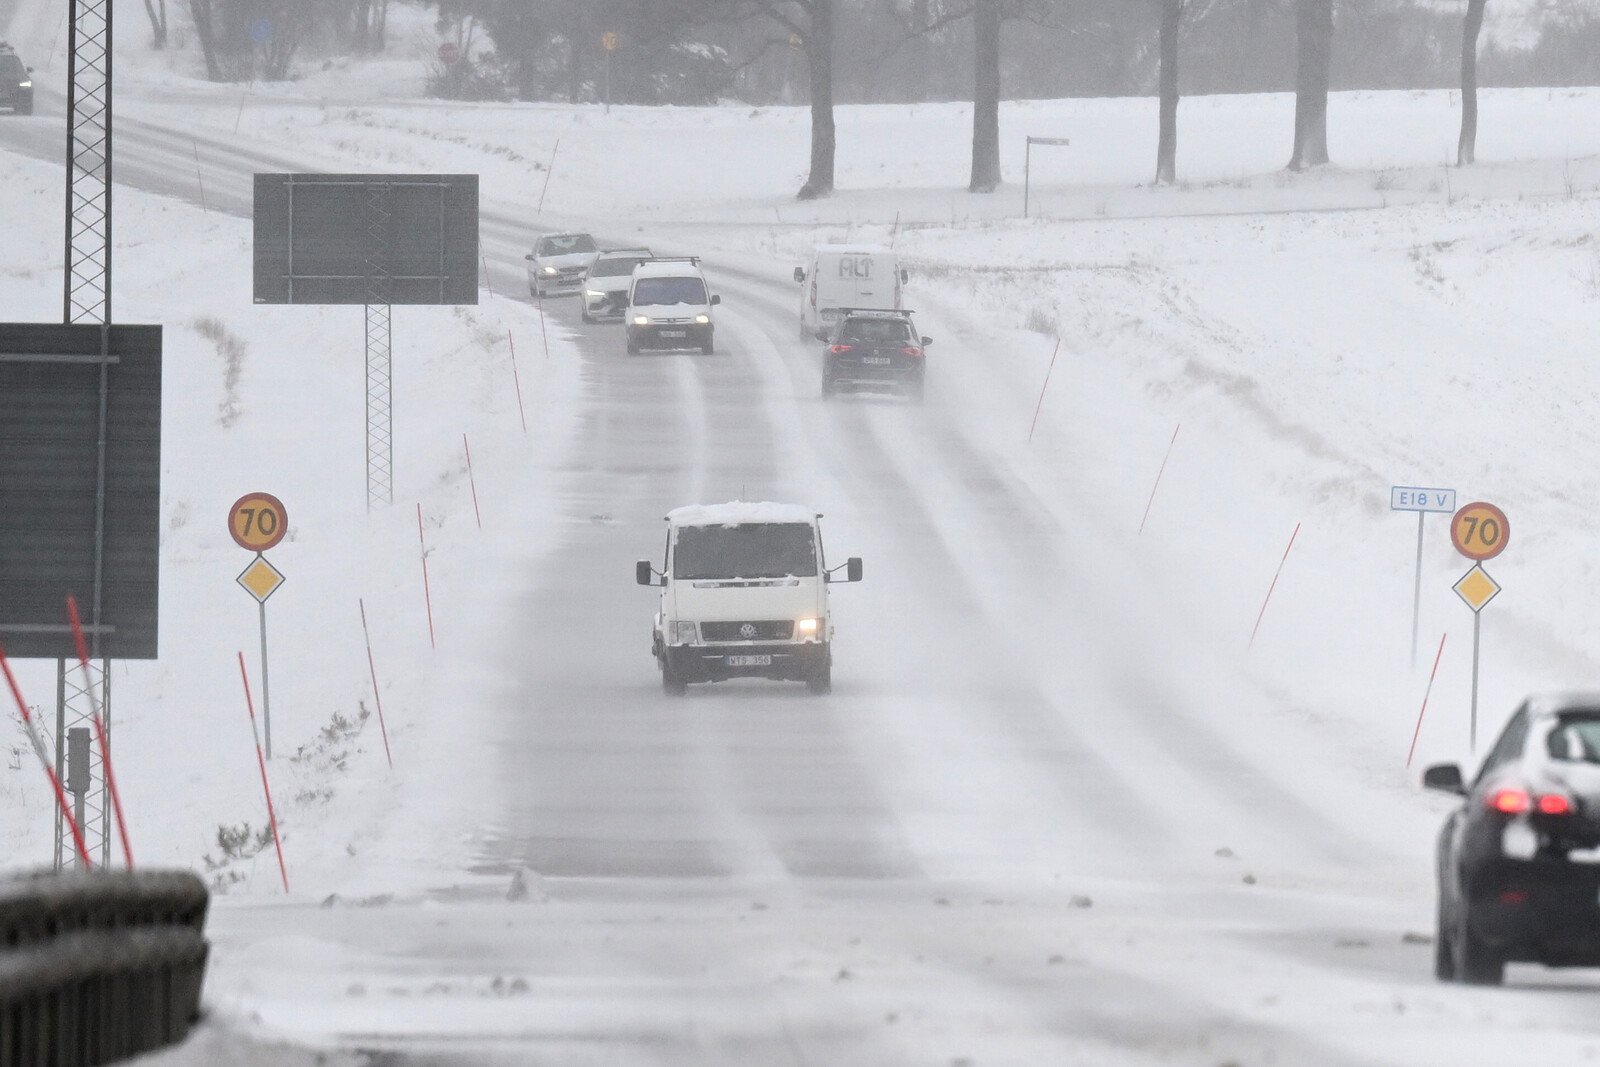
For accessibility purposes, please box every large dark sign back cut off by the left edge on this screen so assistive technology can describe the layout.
[0,323,162,659]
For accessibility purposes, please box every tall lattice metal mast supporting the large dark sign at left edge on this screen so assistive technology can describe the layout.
[54,0,112,869]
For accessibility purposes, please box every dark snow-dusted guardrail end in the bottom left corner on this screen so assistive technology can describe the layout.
[0,870,210,1067]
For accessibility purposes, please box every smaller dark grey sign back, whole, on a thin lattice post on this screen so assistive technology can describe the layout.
[254,174,478,304]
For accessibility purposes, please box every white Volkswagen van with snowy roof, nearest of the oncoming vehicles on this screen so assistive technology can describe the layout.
[634,501,861,696]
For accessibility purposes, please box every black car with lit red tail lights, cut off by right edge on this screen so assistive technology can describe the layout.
[1422,693,1600,985]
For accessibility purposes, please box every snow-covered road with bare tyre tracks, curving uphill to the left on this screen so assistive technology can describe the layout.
[9,51,1600,1067]
